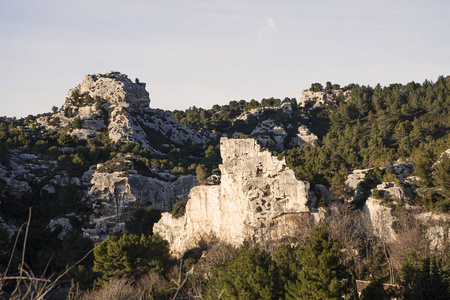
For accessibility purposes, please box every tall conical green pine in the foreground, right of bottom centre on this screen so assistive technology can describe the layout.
[286,226,355,299]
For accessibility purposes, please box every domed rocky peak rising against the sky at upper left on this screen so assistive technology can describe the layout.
[38,71,211,153]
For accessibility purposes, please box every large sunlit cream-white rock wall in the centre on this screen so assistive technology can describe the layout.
[153,138,310,255]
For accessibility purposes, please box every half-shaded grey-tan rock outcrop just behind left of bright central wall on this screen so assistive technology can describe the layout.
[85,159,197,240]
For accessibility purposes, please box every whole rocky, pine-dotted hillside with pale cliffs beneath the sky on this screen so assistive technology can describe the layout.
[0,72,450,298]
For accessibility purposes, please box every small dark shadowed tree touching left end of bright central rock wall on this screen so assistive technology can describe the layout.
[125,206,161,236]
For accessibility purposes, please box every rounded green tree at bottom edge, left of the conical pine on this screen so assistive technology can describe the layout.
[206,244,282,300]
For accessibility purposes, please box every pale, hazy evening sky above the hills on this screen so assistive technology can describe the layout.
[0,0,450,117]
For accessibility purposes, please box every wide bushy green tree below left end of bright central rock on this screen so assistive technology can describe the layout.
[93,234,169,283]
